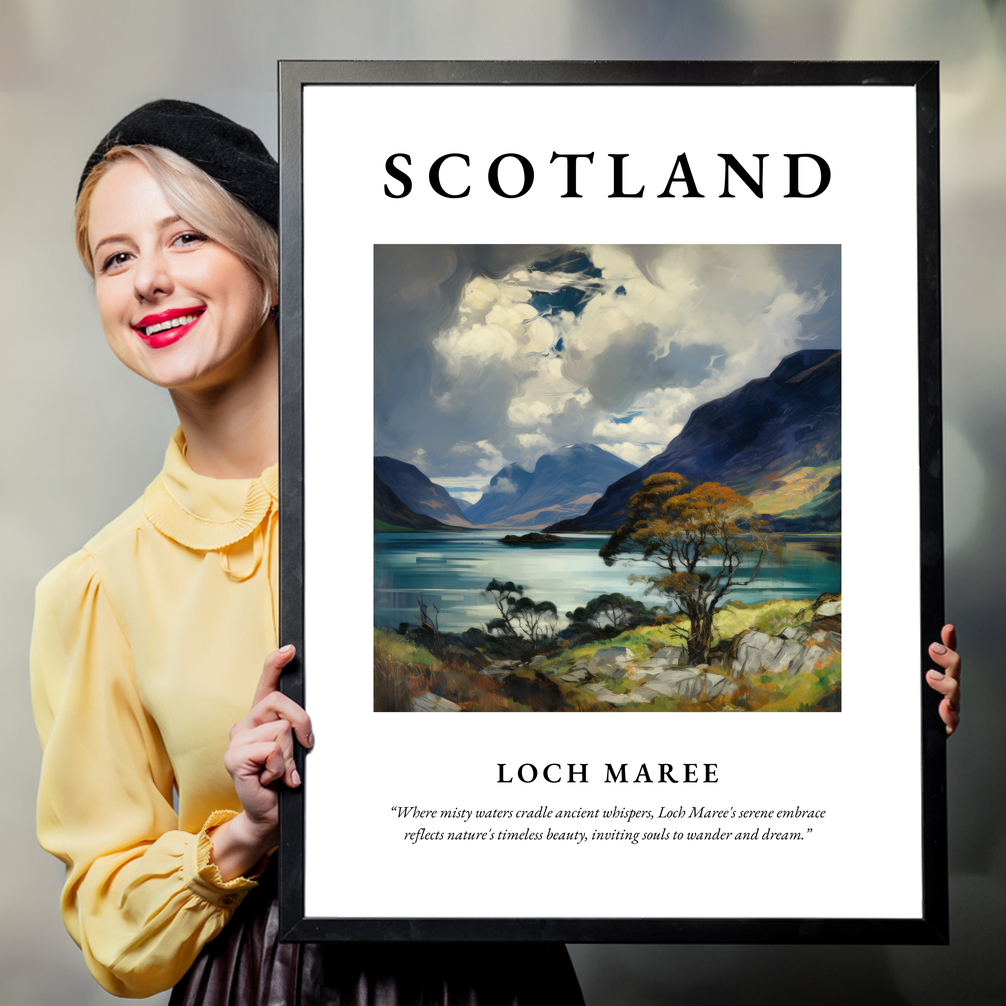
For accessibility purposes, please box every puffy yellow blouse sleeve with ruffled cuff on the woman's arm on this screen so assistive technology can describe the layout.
[31,551,256,997]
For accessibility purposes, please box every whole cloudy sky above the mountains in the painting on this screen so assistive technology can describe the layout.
[374,245,841,501]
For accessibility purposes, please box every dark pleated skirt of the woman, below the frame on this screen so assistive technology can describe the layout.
[169,870,583,1006]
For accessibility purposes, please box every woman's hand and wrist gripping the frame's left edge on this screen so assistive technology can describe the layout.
[209,646,314,880]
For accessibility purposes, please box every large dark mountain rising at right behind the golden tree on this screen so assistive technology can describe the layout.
[543,349,842,533]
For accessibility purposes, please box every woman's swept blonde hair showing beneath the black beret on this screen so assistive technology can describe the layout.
[73,145,280,323]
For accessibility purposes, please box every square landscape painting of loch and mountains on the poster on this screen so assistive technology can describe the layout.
[373,244,842,712]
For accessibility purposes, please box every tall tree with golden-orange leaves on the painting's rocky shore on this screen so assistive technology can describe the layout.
[600,472,781,664]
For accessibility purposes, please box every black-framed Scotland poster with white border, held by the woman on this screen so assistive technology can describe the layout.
[280,62,948,943]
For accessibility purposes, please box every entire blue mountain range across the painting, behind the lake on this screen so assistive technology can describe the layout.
[374,349,842,533]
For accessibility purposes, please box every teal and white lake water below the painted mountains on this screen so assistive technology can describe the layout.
[374,529,842,632]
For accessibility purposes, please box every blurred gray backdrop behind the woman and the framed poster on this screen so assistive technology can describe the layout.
[0,0,1006,1006]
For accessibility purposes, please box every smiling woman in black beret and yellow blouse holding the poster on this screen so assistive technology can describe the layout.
[32,102,582,1006]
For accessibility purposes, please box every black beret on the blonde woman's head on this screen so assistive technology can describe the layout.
[76,99,280,227]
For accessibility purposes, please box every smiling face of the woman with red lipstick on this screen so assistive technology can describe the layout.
[88,158,276,392]
